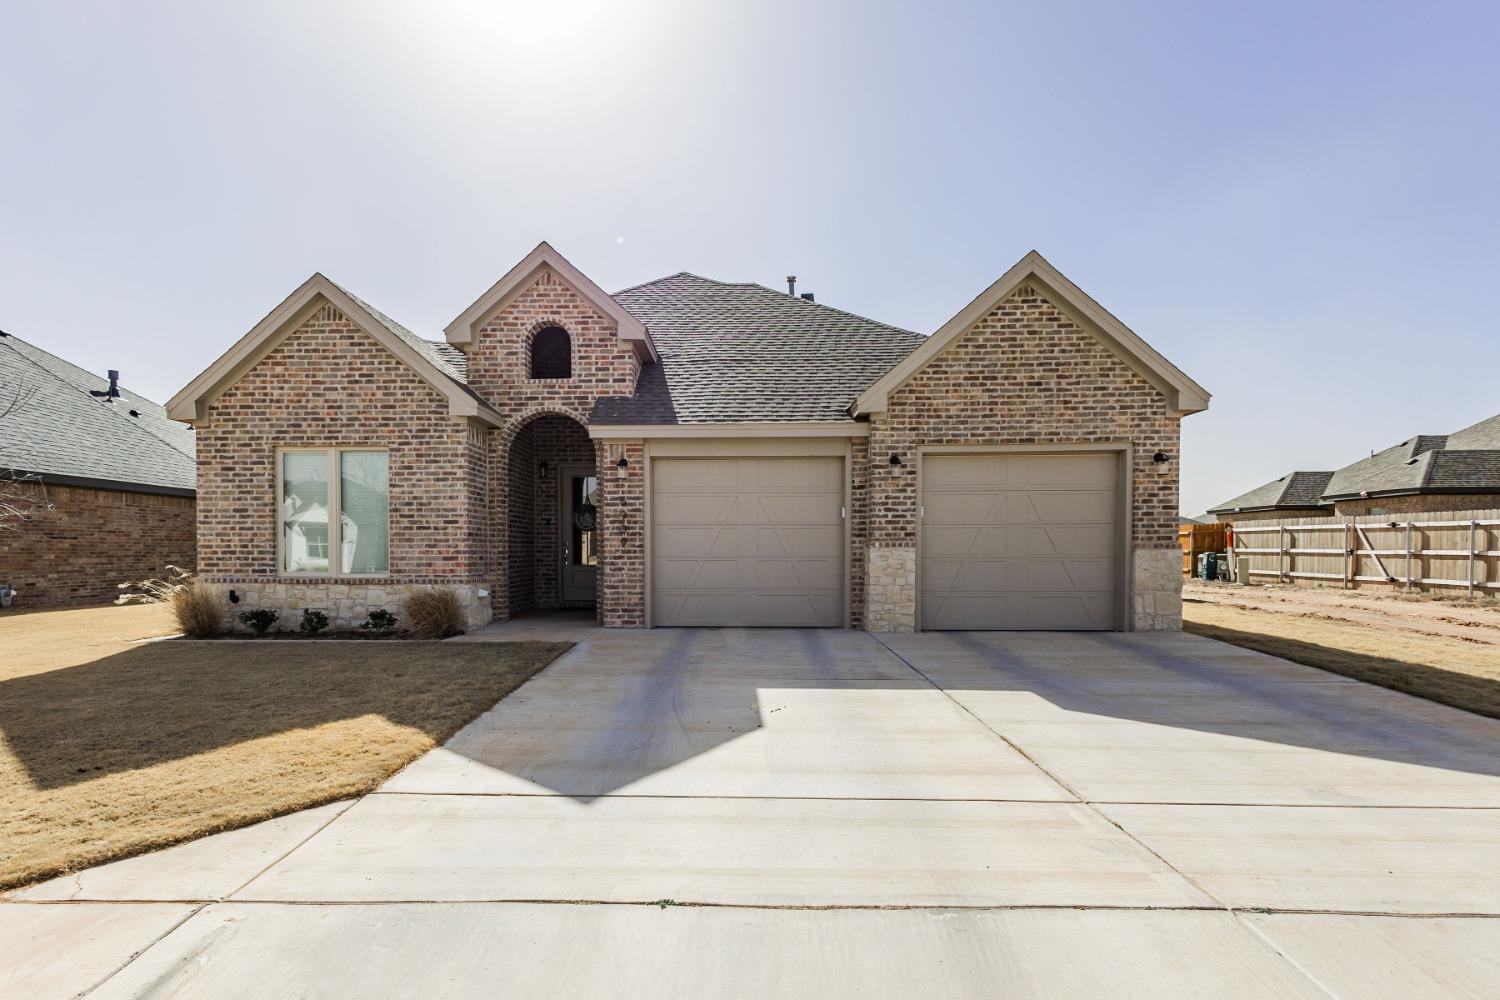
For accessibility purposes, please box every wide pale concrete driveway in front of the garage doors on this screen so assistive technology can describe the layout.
[0,630,1500,999]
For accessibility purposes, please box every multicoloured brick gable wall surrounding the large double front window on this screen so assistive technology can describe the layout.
[198,304,489,582]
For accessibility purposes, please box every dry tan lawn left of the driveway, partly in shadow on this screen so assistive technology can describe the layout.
[0,606,569,889]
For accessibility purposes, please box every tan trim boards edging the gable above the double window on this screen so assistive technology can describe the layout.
[167,274,501,427]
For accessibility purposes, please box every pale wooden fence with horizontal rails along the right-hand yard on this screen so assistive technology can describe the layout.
[1230,510,1500,595]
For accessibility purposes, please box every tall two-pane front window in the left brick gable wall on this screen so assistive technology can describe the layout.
[278,448,390,576]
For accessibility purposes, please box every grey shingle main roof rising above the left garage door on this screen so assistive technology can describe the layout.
[591,271,926,426]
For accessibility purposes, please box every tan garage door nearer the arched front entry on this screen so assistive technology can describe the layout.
[651,459,845,627]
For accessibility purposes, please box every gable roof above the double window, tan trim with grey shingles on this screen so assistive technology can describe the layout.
[167,274,501,427]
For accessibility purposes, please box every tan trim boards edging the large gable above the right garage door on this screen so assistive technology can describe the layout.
[852,250,1209,417]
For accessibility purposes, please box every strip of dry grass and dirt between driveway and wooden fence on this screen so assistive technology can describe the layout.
[1182,580,1500,718]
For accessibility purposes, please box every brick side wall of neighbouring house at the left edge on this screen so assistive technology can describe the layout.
[0,486,197,609]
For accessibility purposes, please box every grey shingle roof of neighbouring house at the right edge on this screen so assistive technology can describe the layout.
[1323,414,1500,501]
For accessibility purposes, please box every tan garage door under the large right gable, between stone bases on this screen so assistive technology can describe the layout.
[921,453,1119,628]
